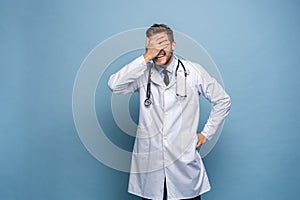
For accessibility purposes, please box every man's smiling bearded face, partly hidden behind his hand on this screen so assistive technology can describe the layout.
[153,32,176,67]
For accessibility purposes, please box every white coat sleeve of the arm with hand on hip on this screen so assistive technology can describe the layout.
[198,63,231,140]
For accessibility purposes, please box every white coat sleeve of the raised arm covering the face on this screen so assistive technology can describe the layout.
[108,56,147,94]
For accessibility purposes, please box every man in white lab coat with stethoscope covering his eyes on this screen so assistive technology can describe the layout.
[108,24,230,200]
